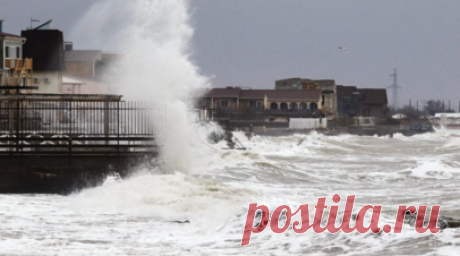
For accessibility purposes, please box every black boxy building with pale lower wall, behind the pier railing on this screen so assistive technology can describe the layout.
[21,21,66,93]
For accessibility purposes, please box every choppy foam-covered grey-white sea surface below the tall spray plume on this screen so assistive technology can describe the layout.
[0,131,460,255]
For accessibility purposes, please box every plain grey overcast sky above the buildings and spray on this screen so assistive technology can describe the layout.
[0,0,460,110]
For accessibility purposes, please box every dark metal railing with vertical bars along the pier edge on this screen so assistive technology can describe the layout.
[0,100,160,155]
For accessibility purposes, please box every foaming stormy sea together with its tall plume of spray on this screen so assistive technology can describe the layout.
[0,0,460,255]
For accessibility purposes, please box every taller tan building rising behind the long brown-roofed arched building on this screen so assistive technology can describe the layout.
[275,78,337,117]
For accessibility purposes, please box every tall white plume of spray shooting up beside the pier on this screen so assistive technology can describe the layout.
[71,0,209,172]
